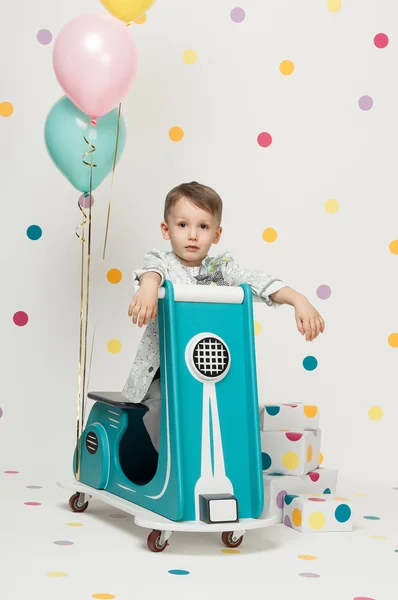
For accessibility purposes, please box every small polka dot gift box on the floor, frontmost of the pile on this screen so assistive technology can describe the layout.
[283,494,352,533]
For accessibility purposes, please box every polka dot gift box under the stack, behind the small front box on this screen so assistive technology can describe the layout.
[262,467,337,523]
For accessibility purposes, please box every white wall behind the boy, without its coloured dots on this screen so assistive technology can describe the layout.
[0,0,398,482]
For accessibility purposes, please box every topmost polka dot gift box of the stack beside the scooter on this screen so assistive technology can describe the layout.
[260,403,319,431]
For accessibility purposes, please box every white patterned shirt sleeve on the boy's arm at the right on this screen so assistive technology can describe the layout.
[215,255,286,308]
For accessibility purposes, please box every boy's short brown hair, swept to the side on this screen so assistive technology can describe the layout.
[164,181,223,225]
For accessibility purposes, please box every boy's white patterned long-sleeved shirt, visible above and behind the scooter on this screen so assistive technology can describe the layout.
[122,249,286,402]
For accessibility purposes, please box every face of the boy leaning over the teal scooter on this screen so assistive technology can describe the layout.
[160,197,222,267]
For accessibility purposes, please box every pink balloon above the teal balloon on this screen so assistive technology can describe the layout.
[53,13,138,119]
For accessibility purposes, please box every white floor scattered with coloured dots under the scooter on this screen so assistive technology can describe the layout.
[0,472,398,600]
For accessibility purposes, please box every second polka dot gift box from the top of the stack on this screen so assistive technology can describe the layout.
[260,429,321,475]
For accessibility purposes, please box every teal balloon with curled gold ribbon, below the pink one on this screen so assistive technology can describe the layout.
[44,96,126,192]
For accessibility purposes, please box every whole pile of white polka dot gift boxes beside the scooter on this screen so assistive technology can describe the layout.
[260,403,351,531]
